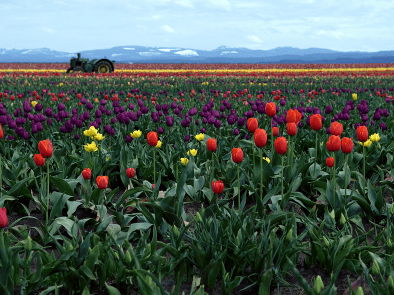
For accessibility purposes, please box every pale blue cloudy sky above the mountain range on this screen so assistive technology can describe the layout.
[0,0,394,53]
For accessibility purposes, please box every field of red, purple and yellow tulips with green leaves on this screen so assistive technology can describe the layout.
[0,63,394,295]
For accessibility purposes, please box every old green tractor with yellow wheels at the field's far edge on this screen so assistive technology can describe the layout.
[67,53,115,74]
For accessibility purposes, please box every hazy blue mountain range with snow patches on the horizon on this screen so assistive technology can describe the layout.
[0,46,394,63]
